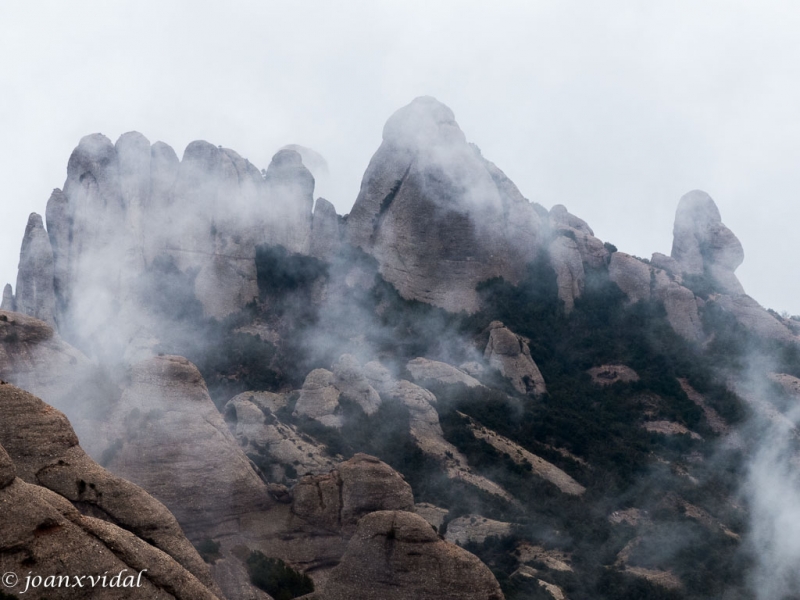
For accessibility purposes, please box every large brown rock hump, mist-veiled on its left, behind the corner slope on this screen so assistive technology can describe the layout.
[99,356,273,538]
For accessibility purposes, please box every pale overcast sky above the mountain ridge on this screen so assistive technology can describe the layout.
[0,0,800,314]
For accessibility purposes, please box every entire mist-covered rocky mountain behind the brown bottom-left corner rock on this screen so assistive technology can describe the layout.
[0,97,800,600]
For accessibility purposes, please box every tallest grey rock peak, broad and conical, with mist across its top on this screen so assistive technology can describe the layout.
[347,97,542,311]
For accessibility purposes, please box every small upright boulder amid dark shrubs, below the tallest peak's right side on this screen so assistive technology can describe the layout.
[483,321,547,396]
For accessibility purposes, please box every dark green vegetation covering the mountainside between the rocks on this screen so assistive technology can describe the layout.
[147,241,800,600]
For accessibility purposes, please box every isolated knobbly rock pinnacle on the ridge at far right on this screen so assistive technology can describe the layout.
[672,190,744,294]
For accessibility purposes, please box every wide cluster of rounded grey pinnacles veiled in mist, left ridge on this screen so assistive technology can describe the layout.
[36,132,324,362]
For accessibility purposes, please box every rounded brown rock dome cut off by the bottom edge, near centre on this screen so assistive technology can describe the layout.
[312,511,503,600]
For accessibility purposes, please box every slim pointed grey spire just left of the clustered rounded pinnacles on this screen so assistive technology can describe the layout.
[14,213,56,327]
